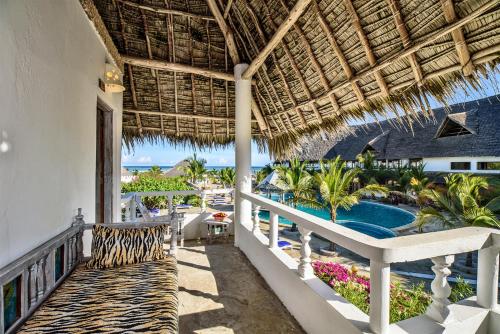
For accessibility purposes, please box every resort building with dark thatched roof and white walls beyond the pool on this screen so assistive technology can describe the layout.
[298,95,500,174]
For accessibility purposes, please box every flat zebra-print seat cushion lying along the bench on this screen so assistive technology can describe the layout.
[19,256,178,334]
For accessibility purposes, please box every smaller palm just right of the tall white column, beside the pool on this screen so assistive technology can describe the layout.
[276,158,314,232]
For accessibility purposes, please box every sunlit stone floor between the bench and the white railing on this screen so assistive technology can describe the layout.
[177,242,304,334]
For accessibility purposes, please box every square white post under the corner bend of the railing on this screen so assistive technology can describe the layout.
[370,260,391,334]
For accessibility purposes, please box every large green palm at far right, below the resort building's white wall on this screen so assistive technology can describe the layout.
[416,174,500,267]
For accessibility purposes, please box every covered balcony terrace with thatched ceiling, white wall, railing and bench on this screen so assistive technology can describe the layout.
[0,0,500,334]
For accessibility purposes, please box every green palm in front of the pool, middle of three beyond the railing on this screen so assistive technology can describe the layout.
[314,157,388,251]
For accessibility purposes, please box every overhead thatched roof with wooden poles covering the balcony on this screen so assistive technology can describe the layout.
[86,0,500,157]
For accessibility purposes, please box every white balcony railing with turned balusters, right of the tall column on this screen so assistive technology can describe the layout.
[240,192,500,333]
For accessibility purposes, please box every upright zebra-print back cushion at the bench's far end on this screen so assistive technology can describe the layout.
[87,225,167,269]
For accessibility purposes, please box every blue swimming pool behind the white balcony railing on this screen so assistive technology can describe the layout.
[259,195,415,239]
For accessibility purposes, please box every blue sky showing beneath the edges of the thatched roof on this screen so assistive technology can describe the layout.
[122,73,500,167]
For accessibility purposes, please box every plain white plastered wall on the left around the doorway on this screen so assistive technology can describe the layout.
[0,0,122,267]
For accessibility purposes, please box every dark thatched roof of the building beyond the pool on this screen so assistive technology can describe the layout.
[297,95,500,161]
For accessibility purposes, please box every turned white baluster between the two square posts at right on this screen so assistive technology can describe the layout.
[426,255,455,324]
